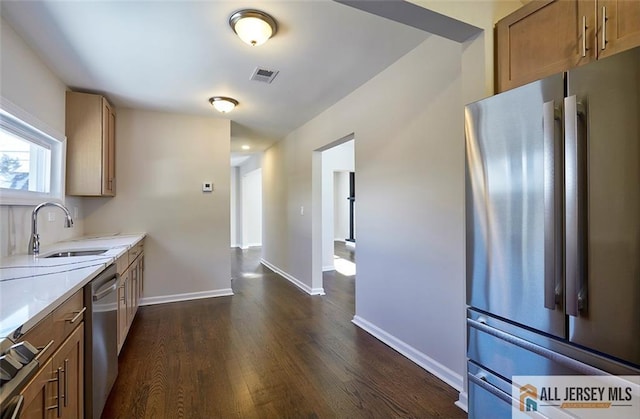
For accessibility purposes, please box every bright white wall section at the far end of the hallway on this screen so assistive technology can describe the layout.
[241,169,262,249]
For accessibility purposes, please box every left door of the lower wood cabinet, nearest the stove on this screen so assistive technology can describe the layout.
[20,360,57,419]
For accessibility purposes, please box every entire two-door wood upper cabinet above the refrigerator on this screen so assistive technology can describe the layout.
[495,0,640,92]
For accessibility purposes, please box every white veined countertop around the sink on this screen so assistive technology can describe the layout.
[0,233,145,338]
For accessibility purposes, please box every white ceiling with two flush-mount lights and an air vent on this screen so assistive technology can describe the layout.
[0,0,429,161]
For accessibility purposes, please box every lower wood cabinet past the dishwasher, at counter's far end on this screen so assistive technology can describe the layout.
[116,241,144,353]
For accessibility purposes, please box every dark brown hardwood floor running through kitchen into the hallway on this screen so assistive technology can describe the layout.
[103,249,466,418]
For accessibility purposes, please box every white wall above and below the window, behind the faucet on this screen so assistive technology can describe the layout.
[0,19,84,256]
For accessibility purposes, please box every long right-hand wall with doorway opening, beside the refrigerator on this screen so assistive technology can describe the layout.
[263,36,466,390]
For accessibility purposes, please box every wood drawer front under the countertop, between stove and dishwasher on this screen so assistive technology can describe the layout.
[19,290,84,360]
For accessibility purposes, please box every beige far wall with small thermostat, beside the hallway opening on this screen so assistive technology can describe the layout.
[85,109,231,303]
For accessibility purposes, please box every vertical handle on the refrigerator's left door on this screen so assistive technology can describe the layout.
[542,101,562,310]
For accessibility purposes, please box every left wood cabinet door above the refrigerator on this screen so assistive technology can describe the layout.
[495,0,595,92]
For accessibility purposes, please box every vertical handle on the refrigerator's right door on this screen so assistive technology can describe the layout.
[564,96,587,317]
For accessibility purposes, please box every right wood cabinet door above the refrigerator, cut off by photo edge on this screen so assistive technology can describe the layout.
[597,0,640,58]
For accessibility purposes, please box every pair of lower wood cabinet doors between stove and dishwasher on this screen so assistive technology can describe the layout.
[20,322,84,419]
